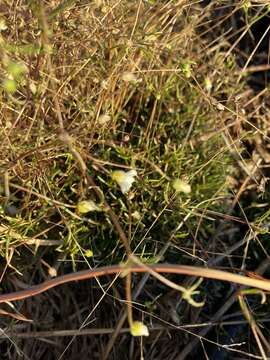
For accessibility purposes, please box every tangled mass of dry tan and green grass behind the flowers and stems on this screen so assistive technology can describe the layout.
[0,0,270,359]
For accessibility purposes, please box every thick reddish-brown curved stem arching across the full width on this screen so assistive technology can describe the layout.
[0,263,270,303]
